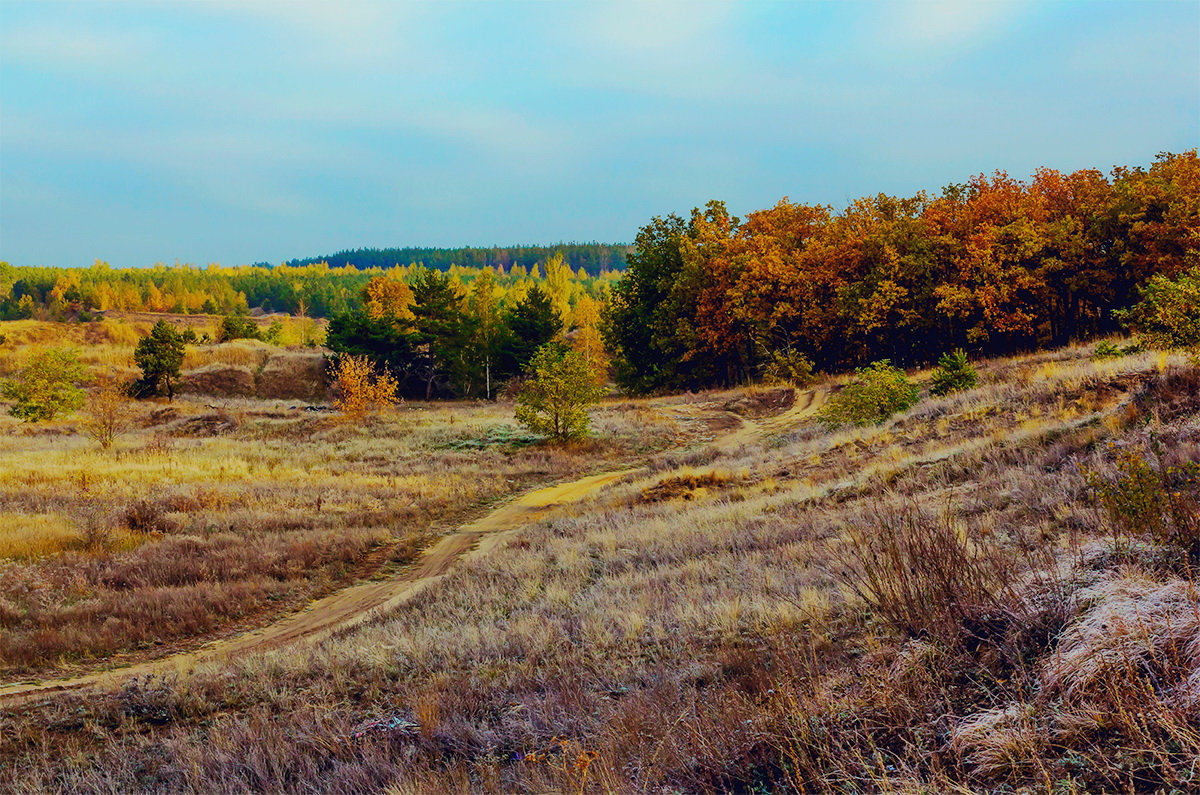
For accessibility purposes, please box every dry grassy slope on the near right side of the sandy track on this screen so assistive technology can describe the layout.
[0,349,1200,793]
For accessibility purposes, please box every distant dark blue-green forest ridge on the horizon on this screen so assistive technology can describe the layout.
[287,243,630,276]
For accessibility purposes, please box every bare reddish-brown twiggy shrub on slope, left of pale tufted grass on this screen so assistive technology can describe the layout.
[833,506,1015,640]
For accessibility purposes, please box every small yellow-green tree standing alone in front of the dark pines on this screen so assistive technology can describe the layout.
[516,342,604,442]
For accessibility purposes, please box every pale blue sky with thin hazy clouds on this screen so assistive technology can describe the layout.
[0,0,1200,267]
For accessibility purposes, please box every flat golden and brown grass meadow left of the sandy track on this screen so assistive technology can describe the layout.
[0,322,688,681]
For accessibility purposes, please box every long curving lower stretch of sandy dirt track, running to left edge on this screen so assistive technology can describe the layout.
[0,470,638,706]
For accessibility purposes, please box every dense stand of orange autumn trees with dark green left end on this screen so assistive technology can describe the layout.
[604,150,1200,391]
